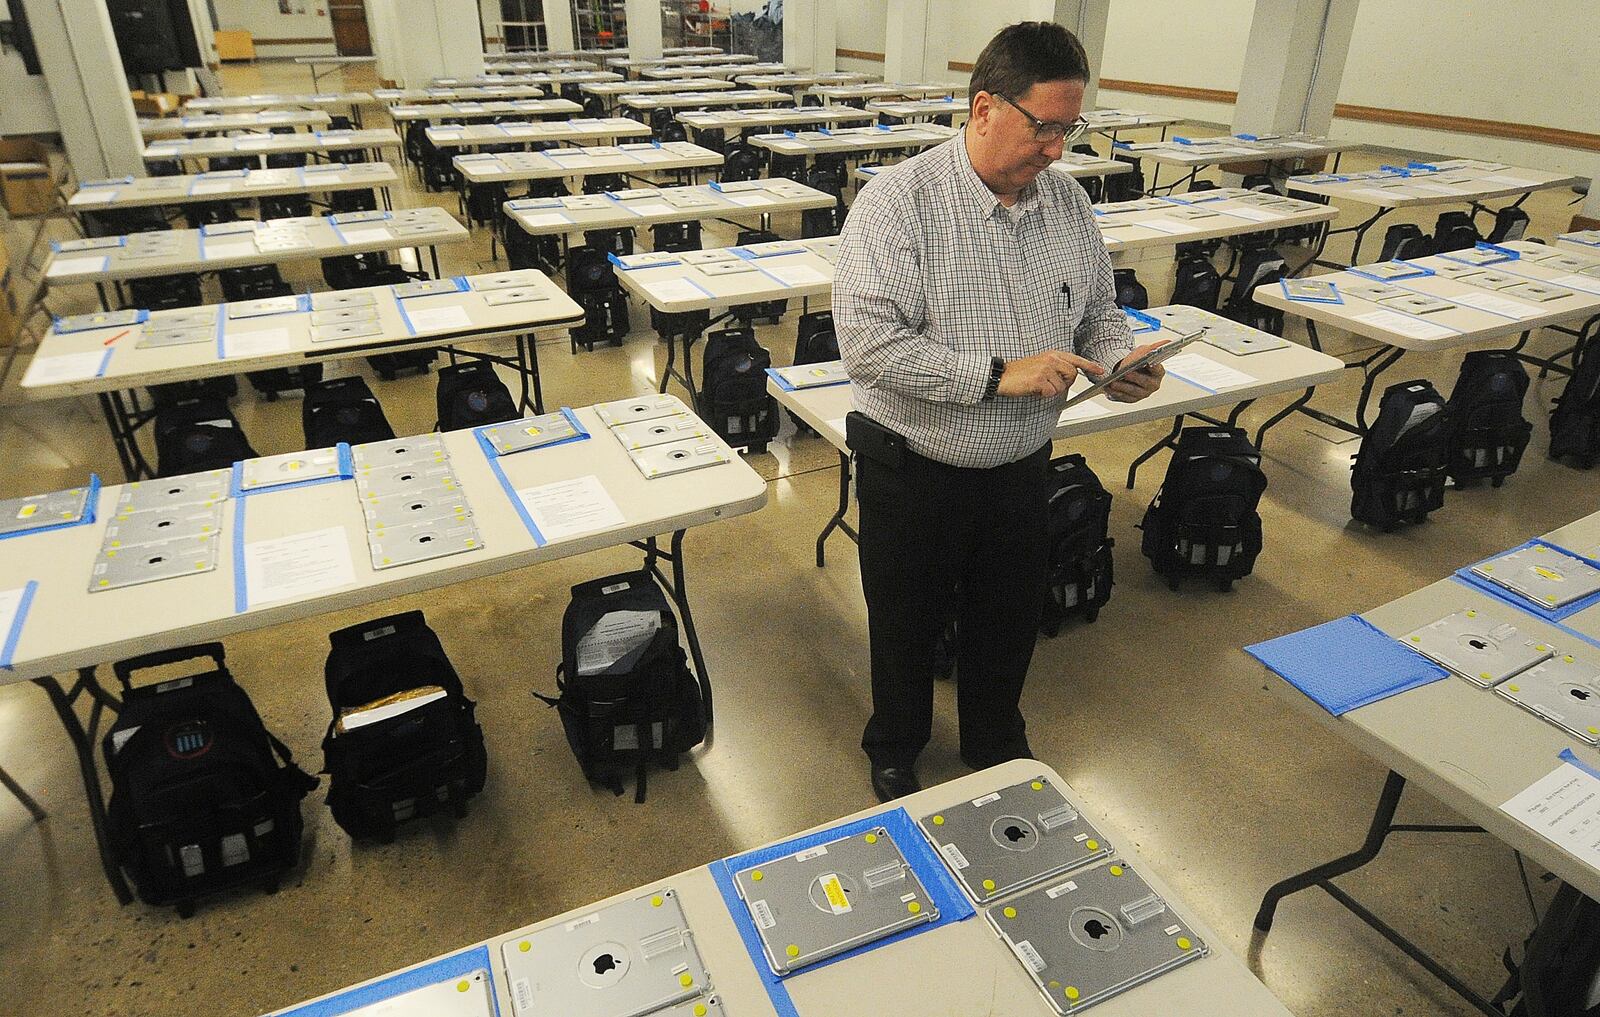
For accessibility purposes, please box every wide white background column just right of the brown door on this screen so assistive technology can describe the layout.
[366,0,483,88]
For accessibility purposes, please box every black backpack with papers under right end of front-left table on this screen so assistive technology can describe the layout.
[534,571,712,801]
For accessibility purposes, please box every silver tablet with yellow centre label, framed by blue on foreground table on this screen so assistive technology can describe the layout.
[733,827,939,977]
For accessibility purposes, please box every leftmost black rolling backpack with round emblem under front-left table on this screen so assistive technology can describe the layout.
[101,643,317,918]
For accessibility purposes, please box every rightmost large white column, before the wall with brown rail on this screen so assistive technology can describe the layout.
[1234,0,1360,134]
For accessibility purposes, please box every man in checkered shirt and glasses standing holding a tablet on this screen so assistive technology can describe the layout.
[834,22,1162,801]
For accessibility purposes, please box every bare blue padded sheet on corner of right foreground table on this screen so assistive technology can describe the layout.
[1245,614,1450,716]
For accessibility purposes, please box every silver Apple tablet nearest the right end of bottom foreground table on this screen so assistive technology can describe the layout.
[984,862,1210,1014]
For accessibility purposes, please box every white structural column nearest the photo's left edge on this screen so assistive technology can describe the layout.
[22,0,144,181]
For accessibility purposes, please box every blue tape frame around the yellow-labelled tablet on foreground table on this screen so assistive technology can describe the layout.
[707,809,976,1017]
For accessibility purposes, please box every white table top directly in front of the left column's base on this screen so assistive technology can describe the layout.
[67,163,398,211]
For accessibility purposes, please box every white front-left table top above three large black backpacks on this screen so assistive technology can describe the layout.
[0,408,766,683]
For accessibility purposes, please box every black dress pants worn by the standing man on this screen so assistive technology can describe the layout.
[856,445,1050,768]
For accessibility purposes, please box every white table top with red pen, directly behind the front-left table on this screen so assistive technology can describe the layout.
[18,269,584,401]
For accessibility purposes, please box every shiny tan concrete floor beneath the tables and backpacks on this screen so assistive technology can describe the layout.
[0,62,1597,1017]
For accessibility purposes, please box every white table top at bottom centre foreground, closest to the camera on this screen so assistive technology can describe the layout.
[278,760,1290,1017]
